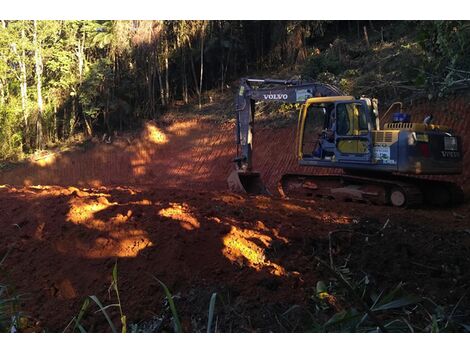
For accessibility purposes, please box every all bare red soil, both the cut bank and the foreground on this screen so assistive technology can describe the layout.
[0,97,470,332]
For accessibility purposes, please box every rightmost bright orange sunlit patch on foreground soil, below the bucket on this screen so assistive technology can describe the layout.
[222,226,286,276]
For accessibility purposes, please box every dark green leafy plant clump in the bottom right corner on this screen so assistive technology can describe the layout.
[312,257,470,332]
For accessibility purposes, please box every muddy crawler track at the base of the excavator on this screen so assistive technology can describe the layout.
[278,174,464,208]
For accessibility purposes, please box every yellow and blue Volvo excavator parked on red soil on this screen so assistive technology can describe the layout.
[227,78,464,207]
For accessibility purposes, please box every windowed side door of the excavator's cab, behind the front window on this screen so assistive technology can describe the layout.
[334,100,372,163]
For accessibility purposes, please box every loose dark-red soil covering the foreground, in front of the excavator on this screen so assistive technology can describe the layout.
[0,187,470,332]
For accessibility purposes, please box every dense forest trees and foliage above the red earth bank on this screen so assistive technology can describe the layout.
[0,20,470,159]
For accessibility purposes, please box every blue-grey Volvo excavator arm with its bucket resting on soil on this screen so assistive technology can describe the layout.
[228,78,343,193]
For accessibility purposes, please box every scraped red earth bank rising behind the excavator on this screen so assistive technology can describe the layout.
[0,96,470,191]
